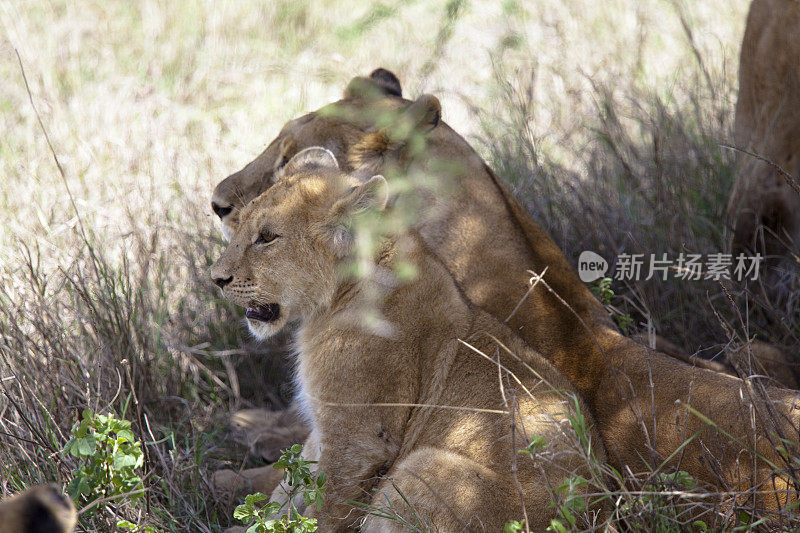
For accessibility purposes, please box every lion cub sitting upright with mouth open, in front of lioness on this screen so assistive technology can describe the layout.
[212,148,605,532]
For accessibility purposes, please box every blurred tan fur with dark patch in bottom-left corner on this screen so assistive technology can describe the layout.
[0,485,78,533]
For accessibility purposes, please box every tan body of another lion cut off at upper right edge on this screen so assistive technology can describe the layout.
[728,0,800,262]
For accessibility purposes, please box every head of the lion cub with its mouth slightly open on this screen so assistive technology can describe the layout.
[211,147,387,339]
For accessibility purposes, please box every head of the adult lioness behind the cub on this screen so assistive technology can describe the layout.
[211,69,441,240]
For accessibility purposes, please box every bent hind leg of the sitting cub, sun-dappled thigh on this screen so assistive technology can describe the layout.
[361,448,553,533]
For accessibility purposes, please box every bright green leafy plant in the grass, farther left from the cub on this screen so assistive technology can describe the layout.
[66,409,144,506]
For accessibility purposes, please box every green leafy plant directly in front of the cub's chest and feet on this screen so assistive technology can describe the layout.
[233,444,326,533]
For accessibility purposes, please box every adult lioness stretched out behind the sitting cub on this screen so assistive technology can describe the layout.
[212,70,798,507]
